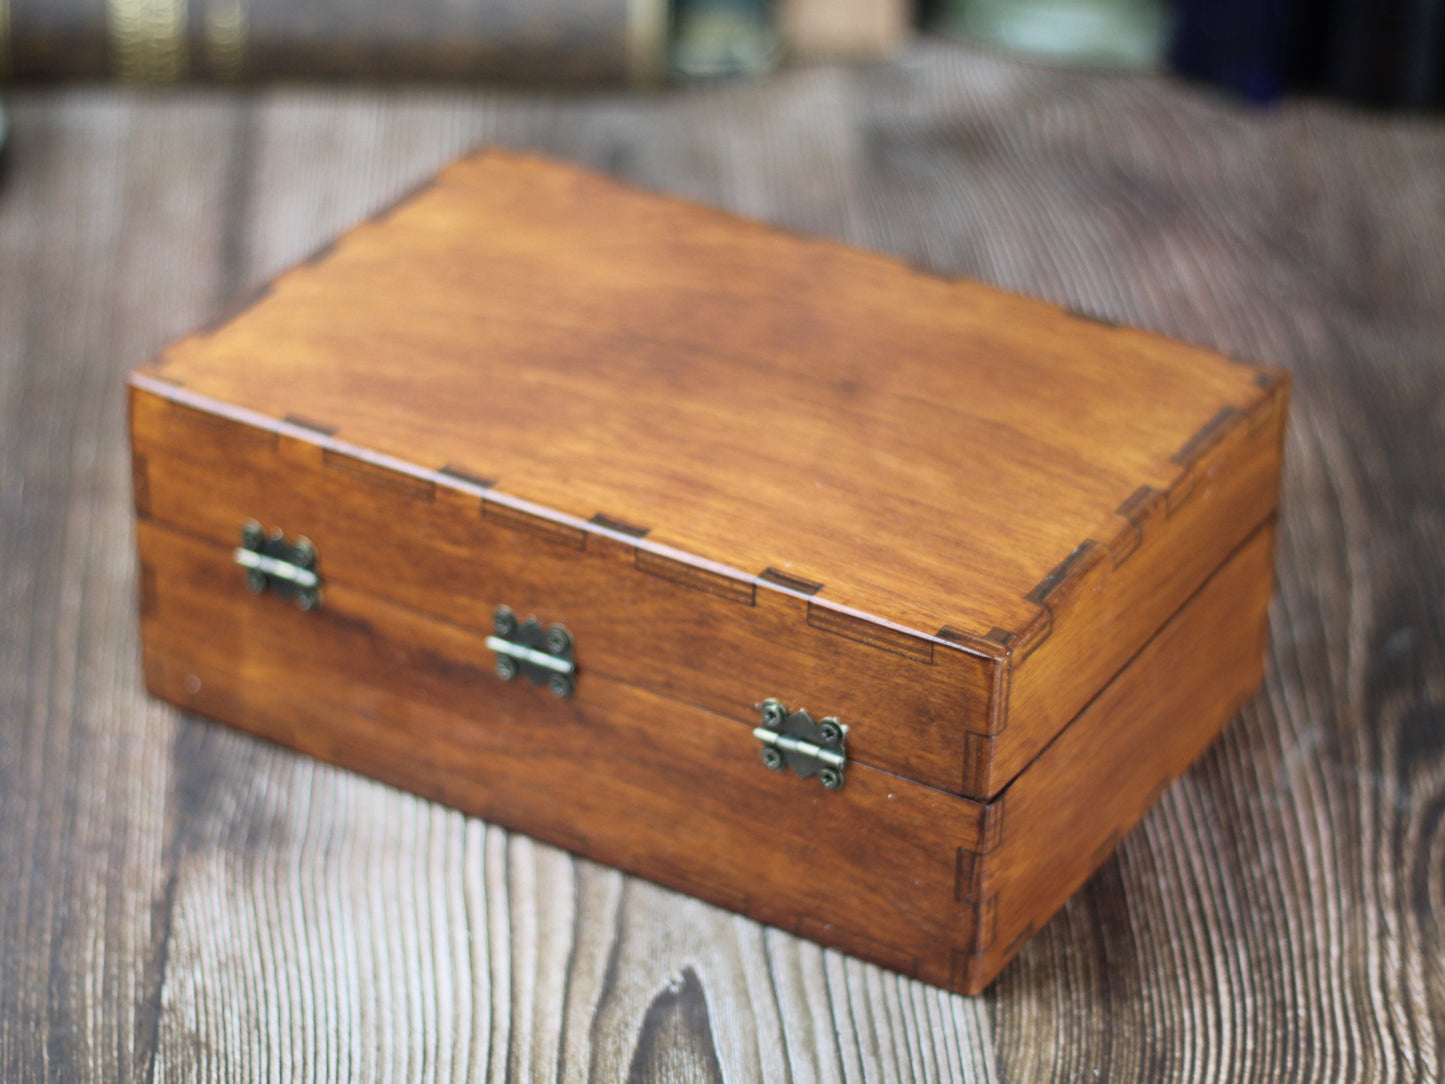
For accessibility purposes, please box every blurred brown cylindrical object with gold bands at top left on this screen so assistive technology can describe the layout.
[0,0,668,84]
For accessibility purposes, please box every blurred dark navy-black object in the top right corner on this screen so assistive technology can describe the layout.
[1170,0,1445,108]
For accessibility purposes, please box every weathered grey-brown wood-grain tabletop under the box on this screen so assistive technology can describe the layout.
[0,46,1445,1081]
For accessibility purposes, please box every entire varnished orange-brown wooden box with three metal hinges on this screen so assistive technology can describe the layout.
[130,153,1287,991]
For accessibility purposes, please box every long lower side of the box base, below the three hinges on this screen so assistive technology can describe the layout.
[139,520,988,984]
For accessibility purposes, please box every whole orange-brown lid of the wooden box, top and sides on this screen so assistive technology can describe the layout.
[133,152,1286,798]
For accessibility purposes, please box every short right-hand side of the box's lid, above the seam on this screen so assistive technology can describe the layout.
[982,374,1289,798]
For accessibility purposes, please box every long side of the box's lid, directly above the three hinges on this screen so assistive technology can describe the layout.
[131,387,1001,792]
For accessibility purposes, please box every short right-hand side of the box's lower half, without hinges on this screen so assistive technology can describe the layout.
[954,520,1274,993]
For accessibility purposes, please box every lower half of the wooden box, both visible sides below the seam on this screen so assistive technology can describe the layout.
[139,520,1273,993]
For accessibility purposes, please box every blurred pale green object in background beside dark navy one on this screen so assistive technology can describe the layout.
[945,0,1170,68]
